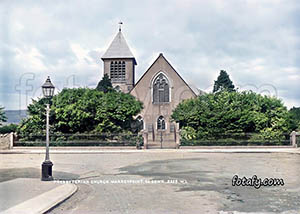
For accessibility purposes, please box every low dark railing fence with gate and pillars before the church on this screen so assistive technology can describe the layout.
[5,131,300,149]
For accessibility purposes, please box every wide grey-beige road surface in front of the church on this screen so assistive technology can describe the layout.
[0,151,300,214]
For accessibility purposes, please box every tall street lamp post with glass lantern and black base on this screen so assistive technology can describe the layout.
[42,76,55,181]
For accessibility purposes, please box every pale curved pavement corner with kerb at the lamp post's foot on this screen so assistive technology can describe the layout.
[0,178,77,214]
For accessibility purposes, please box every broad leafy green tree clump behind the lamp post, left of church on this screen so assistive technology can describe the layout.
[18,88,142,138]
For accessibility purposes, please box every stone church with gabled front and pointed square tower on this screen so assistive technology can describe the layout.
[101,28,199,148]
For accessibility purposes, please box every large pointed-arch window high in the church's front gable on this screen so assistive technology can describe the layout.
[153,74,170,103]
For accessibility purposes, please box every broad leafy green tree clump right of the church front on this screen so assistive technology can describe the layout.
[171,90,289,144]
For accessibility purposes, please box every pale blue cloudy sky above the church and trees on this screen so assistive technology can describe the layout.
[0,0,300,110]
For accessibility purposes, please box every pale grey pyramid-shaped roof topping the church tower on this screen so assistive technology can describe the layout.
[101,30,136,64]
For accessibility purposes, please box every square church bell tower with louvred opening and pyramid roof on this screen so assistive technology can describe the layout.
[101,26,137,93]
